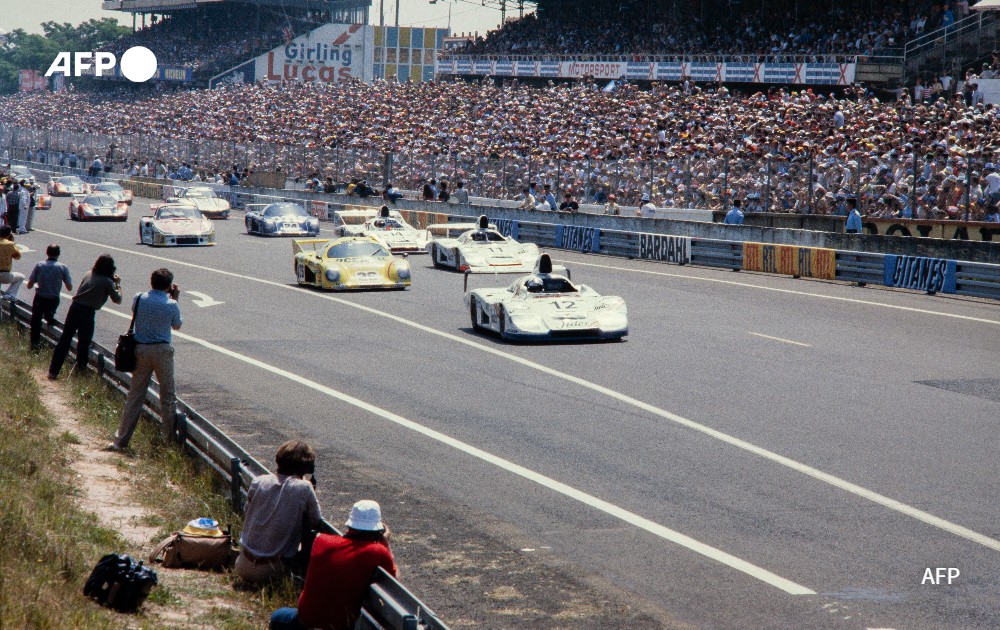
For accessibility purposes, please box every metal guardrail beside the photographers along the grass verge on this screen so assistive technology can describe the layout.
[0,301,448,630]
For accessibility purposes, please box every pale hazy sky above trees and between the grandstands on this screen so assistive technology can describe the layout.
[0,0,517,35]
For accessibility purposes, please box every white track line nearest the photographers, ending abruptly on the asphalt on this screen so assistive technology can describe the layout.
[90,308,816,595]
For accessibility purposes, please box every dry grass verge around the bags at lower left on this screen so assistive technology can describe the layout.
[0,325,297,630]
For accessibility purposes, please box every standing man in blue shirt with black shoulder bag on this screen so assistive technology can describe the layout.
[108,269,181,451]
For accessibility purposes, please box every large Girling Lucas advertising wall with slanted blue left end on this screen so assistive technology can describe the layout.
[210,24,373,88]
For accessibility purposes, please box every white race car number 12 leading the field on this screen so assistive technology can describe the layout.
[465,254,628,341]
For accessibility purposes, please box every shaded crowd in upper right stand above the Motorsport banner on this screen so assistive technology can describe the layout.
[457,0,969,57]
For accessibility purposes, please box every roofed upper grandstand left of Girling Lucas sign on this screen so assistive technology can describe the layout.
[96,0,371,85]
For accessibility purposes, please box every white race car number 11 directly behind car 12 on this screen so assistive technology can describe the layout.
[427,215,538,273]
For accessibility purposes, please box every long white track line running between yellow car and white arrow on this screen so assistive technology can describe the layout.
[43,230,1000,551]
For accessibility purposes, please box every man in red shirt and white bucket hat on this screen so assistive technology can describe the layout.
[270,500,396,630]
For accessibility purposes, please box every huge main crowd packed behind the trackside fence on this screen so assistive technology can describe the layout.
[0,73,1000,218]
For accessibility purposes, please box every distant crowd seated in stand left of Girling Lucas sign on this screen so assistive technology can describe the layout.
[97,3,329,76]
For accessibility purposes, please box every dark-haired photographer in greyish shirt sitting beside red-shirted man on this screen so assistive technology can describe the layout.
[236,440,322,584]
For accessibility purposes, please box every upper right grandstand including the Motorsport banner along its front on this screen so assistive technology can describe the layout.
[443,0,998,85]
